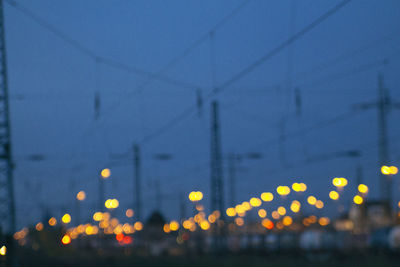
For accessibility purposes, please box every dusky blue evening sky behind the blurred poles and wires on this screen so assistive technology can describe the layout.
[4,0,400,230]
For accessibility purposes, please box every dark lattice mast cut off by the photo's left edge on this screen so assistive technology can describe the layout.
[0,0,17,266]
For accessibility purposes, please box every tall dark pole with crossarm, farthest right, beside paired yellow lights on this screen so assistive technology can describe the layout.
[358,74,400,209]
